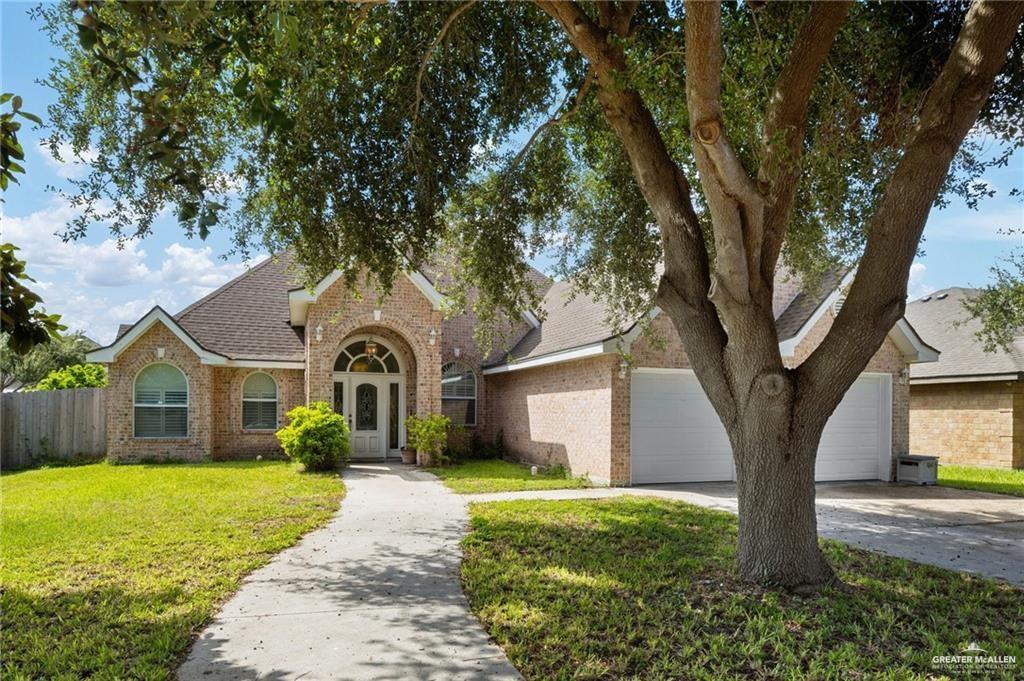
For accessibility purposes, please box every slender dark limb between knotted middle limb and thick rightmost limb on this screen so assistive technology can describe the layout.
[758,0,852,278]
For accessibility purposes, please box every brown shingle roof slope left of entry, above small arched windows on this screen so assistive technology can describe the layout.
[174,252,305,361]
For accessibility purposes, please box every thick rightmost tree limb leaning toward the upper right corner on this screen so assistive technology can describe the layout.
[796,0,1024,413]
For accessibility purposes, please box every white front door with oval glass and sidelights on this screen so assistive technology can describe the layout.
[334,374,403,459]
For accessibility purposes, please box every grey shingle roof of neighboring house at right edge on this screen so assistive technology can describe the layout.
[905,287,1024,380]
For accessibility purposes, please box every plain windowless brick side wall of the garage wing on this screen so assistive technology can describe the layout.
[487,355,629,482]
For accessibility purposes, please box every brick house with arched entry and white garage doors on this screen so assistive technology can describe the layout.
[89,254,936,484]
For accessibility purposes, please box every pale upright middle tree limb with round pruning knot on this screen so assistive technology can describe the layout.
[686,1,770,307]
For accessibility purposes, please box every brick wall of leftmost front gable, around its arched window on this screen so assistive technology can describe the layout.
[106,323,213,462]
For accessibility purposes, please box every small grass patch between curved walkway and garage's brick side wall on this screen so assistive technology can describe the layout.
[427,459,590,495]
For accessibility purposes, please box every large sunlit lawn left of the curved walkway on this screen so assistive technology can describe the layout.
[0,462,344,681]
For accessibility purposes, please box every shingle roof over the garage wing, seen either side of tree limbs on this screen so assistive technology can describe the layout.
[498,269,849,364]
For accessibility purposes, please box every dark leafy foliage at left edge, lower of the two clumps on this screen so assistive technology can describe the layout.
[0,244,67,354]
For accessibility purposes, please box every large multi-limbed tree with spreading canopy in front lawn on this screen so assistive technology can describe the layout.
[41,0,1024,587]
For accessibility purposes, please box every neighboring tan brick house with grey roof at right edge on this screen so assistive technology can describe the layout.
[906,288,1024,468]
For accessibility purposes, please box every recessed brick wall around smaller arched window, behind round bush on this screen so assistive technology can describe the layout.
[212,367,305,459]
